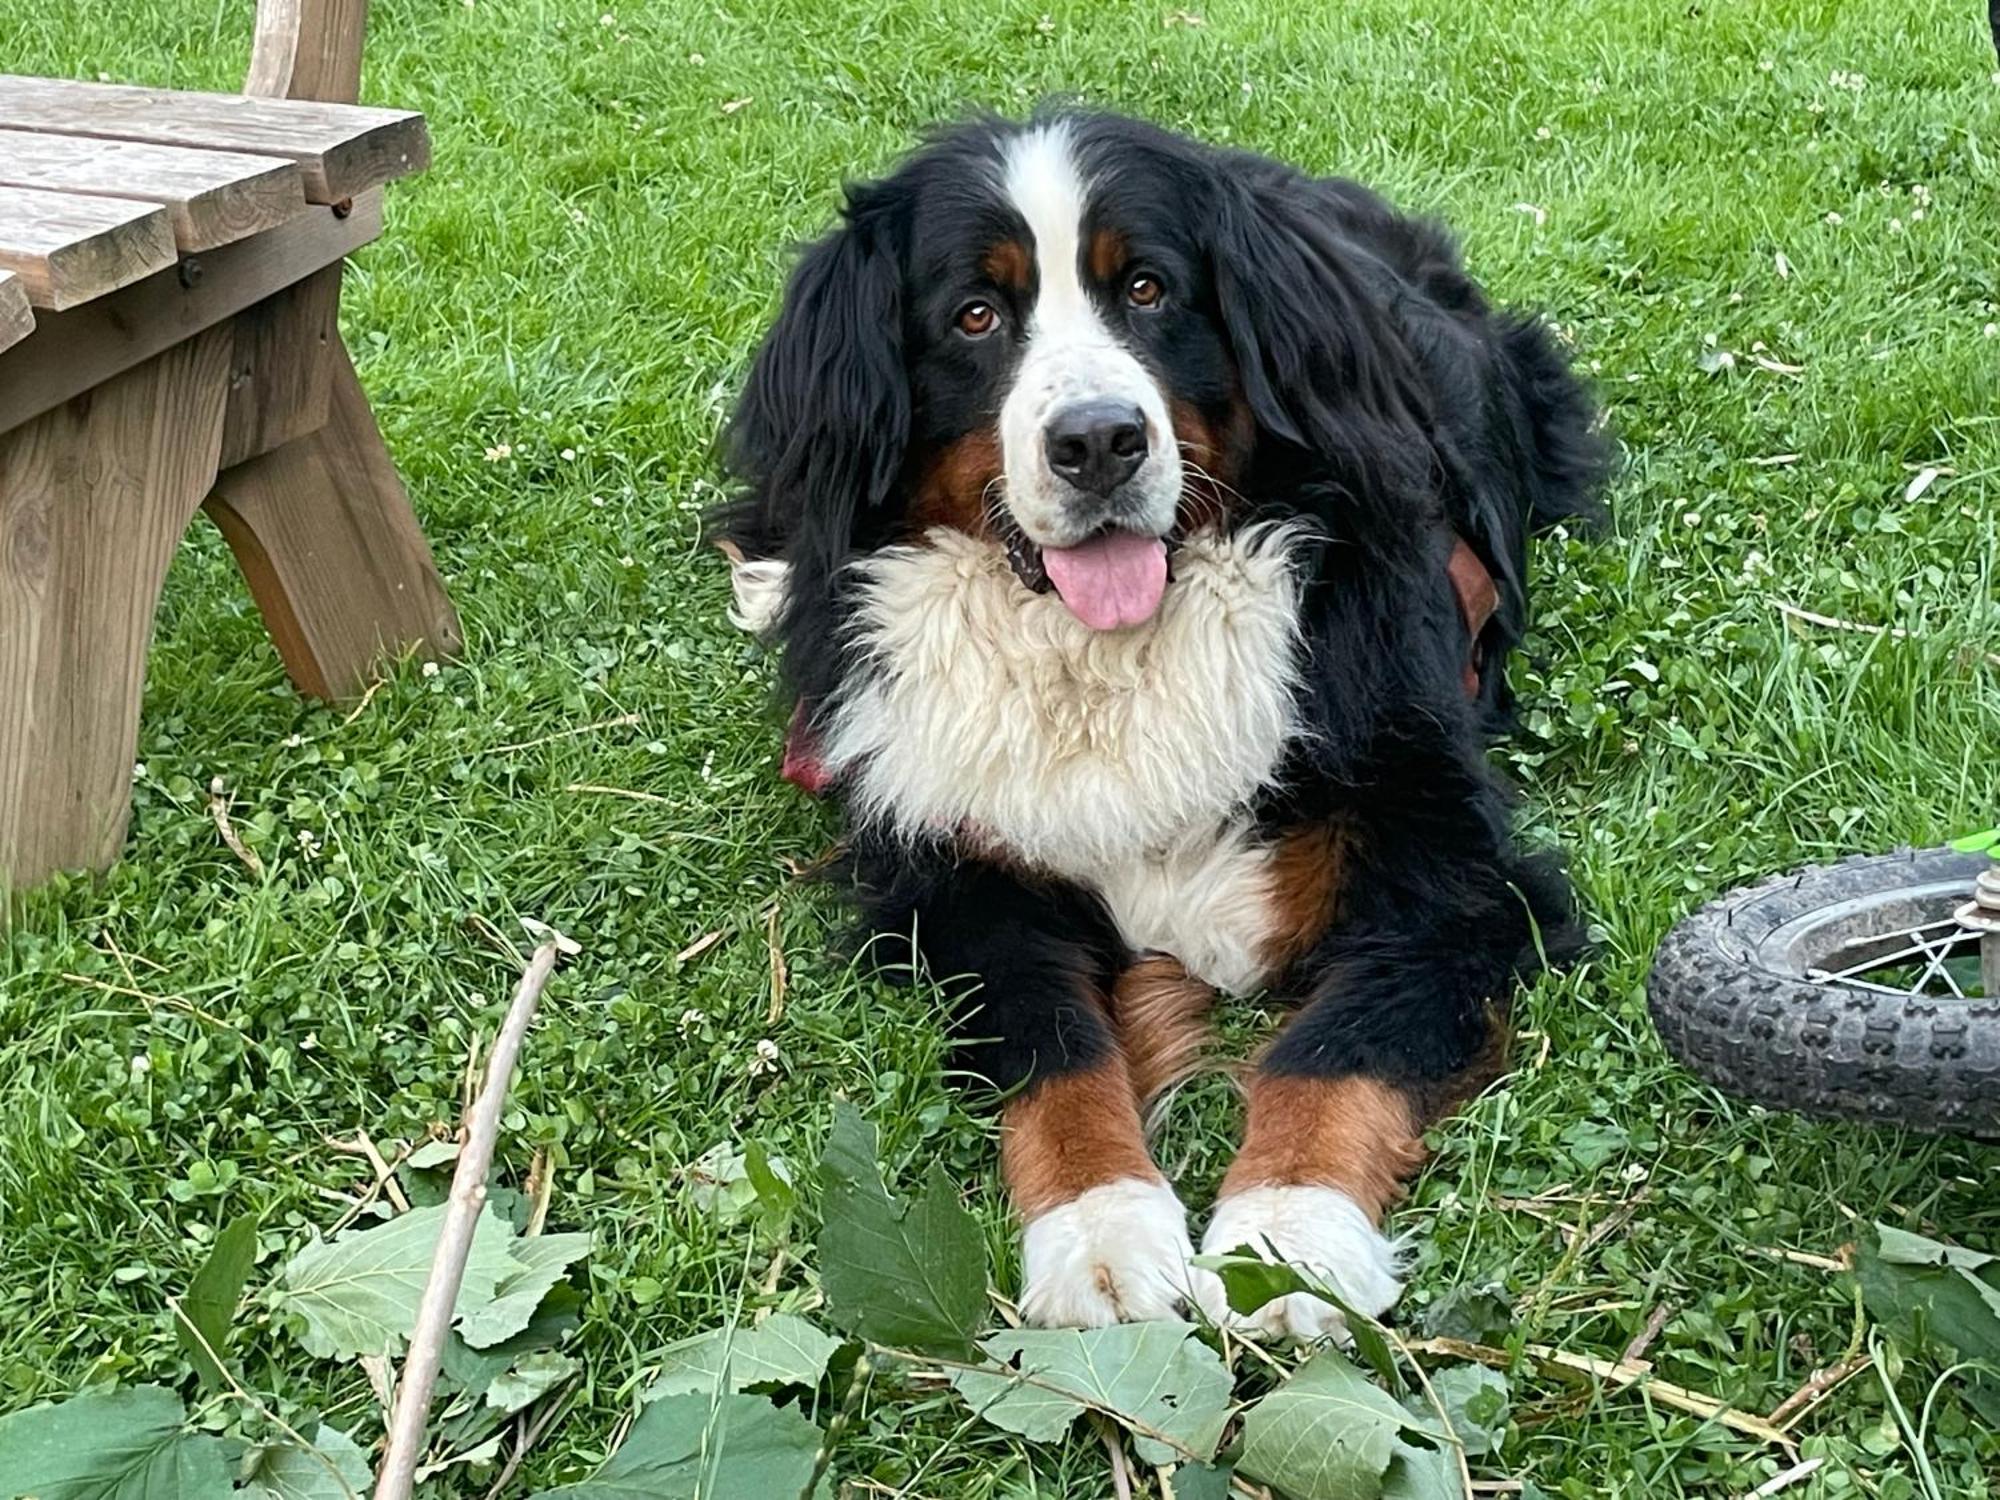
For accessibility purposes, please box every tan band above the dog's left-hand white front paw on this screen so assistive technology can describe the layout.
[1000,1052,1166,1220]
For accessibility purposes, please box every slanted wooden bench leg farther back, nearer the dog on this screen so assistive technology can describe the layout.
[208,348,462,700]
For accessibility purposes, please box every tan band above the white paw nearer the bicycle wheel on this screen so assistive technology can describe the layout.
[1216,1074,1424,1222]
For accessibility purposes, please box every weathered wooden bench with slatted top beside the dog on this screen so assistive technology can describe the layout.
[0,0,460,892]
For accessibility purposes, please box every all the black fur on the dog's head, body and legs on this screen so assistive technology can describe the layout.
[718,116,1608,1102]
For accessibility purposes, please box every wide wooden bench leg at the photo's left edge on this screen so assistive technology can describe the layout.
[0,328,230,890]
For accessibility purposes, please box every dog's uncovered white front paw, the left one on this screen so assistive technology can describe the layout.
[1020,1178,1214,1328]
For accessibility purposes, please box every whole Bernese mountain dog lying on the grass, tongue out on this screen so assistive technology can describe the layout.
[716,110,1608,1338]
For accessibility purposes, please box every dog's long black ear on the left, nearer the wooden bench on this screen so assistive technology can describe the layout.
[718,176,910,576]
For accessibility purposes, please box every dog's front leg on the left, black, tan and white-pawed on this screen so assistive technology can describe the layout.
[862,854,1194,1326]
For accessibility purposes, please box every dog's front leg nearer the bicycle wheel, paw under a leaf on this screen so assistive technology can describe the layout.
[1202,774,1568,1338]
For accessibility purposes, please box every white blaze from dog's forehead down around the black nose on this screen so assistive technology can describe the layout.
[1000,120,1180,546]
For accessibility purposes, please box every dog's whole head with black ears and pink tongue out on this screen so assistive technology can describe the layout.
[732,116,1440,630]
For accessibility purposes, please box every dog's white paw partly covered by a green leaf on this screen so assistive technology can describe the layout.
[1198,1188,1402,1340]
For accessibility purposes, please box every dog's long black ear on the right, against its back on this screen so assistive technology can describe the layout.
[1208,158,1436,502]
